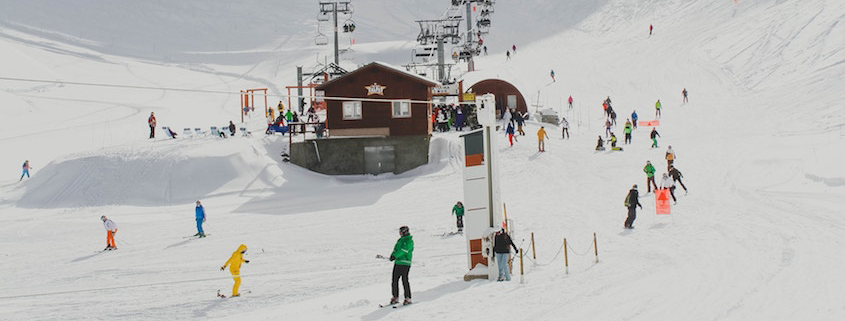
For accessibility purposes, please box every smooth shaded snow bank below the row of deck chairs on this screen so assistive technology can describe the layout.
[18,139,278,208]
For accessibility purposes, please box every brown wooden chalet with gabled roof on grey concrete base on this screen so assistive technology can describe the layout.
[291,62,438,175]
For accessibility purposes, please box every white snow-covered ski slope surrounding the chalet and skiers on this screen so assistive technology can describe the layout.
[0,0,845,320]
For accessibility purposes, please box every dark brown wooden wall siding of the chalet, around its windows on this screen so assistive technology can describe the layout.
[320,66,431,136]
